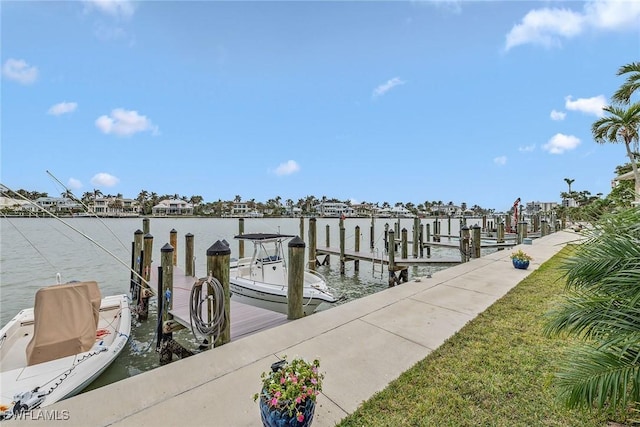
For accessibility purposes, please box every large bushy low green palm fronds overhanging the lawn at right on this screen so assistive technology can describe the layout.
[545,207,640,409]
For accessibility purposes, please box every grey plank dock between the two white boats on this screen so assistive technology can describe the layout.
[151,266,289,341]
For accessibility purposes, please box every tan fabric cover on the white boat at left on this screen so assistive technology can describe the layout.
[27,282,101,366]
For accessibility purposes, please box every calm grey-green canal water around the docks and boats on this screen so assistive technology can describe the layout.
[0,218,481,389]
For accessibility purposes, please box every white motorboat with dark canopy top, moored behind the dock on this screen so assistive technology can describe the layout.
[229,233,337,315]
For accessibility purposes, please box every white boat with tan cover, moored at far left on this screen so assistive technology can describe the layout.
[0,282,131,420]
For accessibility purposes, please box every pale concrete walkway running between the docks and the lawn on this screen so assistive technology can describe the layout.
[42,231,579,427]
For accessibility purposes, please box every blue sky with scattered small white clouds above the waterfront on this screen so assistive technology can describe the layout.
[0,0,640,210]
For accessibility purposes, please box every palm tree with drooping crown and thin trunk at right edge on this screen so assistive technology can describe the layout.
[591,102,640,201]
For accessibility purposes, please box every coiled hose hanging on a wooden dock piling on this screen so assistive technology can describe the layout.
[189,277,227,343]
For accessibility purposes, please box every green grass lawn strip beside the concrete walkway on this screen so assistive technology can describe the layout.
[339,248,632,427]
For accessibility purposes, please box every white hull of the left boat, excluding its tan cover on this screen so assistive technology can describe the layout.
[0,295,131,419]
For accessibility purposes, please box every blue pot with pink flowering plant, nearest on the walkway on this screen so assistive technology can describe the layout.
[253,356,324,427]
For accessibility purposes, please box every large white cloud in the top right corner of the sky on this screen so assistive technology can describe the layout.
[505,0,640,50]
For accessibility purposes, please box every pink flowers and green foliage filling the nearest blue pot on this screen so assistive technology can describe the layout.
[253,356,324,422]
